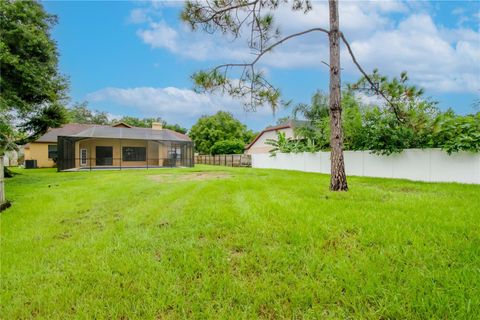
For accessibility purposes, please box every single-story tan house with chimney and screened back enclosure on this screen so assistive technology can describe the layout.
[25,123,193,171]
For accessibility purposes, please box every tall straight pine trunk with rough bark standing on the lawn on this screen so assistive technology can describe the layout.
[329,0,348,191]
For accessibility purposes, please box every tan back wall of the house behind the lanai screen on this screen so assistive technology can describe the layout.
[75,139,167,168]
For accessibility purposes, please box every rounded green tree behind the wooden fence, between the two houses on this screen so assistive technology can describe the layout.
[189,111,253,154]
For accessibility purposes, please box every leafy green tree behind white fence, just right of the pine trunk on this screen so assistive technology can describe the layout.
[348,70,439,154]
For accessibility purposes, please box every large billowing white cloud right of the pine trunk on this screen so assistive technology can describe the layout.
[344,14,480,92]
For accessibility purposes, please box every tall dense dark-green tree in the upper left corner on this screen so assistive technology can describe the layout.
[0,0,67,118]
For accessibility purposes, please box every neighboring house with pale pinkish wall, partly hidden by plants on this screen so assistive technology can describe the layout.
[245,120,306,154]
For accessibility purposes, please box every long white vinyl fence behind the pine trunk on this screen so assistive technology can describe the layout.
[252,149,480,184]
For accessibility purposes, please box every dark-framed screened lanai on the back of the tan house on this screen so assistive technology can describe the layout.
[57,126,194,171]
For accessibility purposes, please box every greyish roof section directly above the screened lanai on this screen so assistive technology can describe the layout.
[65,126,191,141]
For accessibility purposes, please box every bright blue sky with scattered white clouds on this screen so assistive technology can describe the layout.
[43,0,480,130]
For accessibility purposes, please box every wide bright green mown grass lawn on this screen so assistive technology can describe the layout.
[0,166,480,319]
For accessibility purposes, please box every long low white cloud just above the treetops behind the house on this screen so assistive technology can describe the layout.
[86,87,271,122]
